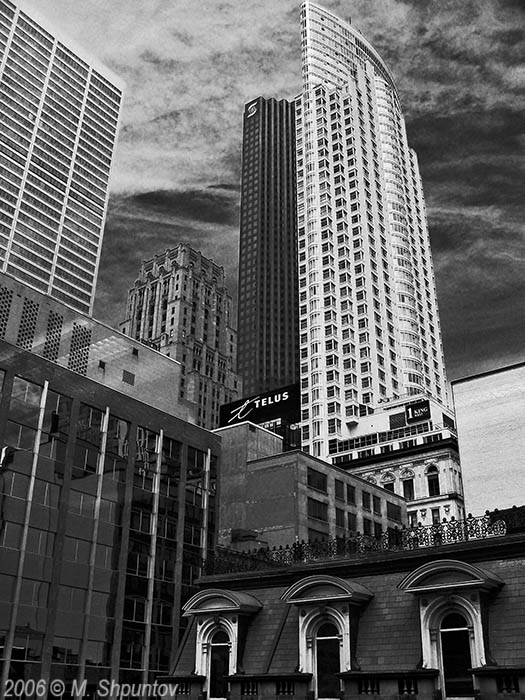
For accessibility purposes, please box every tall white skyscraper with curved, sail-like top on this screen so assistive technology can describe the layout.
[296,2,447,458]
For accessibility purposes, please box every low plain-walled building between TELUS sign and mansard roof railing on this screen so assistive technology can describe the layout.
[215,422,407,549]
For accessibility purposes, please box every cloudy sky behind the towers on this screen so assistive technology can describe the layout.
[35,0,525,379]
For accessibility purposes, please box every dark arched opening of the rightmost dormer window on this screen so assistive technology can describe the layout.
[440,612,474,698]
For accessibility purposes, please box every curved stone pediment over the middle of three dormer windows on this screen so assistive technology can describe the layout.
[281,576,373,604]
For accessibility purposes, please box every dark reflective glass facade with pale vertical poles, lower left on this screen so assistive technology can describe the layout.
[0,340,219,697]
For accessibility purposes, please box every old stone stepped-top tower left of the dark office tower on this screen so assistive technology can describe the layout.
[120,244,241,429]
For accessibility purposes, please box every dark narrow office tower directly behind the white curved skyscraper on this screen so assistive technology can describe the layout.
[238,97,299,396]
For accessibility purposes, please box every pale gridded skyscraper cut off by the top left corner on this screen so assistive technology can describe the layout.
[0,0,123,313]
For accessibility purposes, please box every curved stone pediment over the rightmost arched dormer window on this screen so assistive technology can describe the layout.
[398,559,503,593]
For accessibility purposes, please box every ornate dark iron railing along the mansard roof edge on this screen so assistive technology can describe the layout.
[203,513,507,575]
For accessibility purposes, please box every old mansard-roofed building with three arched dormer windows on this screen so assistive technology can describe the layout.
[164,508,525,700]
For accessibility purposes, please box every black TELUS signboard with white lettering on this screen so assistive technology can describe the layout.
[219,384,301,428]
